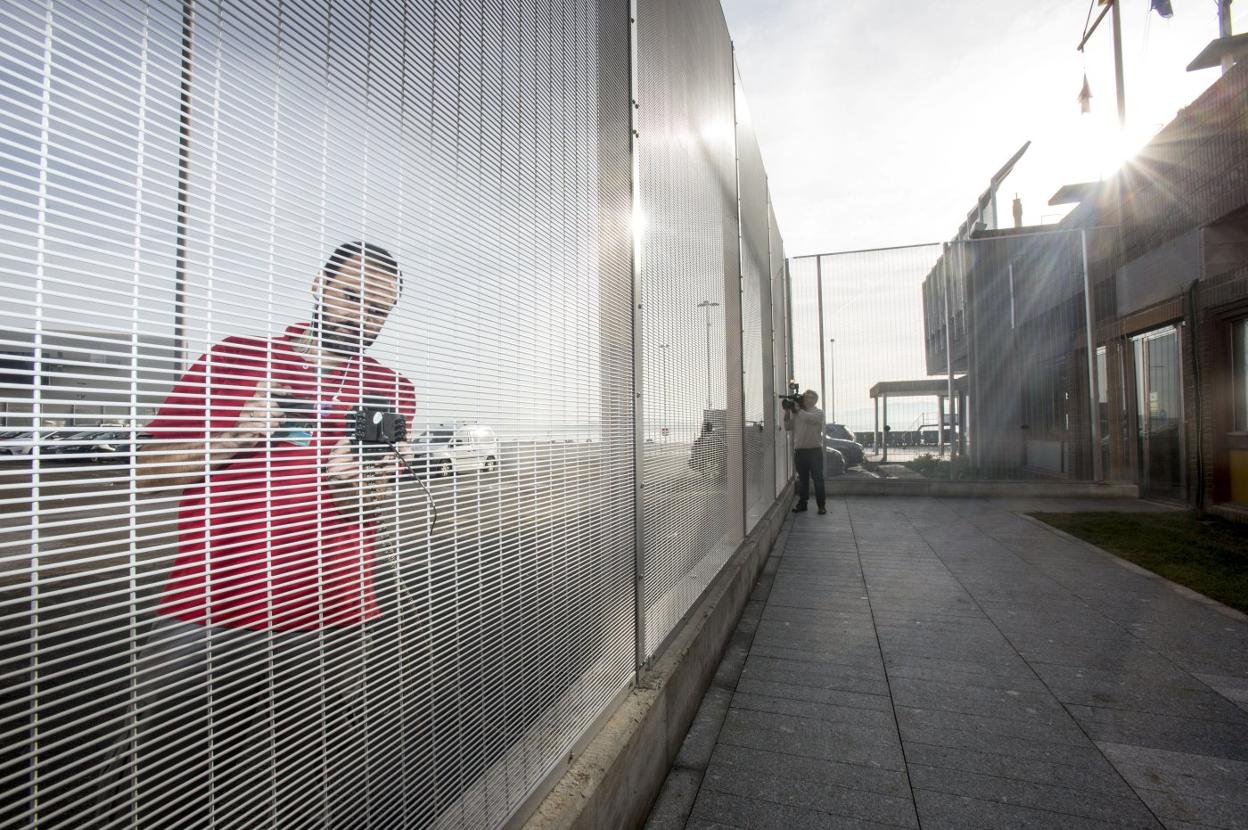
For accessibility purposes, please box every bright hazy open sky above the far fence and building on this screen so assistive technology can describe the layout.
[723,0,1248,256]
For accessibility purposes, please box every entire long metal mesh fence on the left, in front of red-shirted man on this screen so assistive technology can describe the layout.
[0,0,787,829]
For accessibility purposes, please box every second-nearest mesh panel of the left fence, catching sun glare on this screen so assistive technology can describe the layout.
[638,0,740,655]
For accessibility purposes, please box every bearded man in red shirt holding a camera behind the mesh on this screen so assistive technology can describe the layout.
[101,242,416,826]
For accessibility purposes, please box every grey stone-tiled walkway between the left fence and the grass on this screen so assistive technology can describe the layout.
[646,497,1248,830]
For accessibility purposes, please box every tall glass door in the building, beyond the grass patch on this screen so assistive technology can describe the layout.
[1132,326,1183,500]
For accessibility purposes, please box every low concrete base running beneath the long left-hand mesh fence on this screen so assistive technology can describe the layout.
[522,483,792,830]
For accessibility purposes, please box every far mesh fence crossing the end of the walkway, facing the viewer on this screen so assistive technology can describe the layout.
[791,228,1108,481]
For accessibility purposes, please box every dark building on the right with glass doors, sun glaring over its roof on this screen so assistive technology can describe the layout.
[924,58,1248,517]
